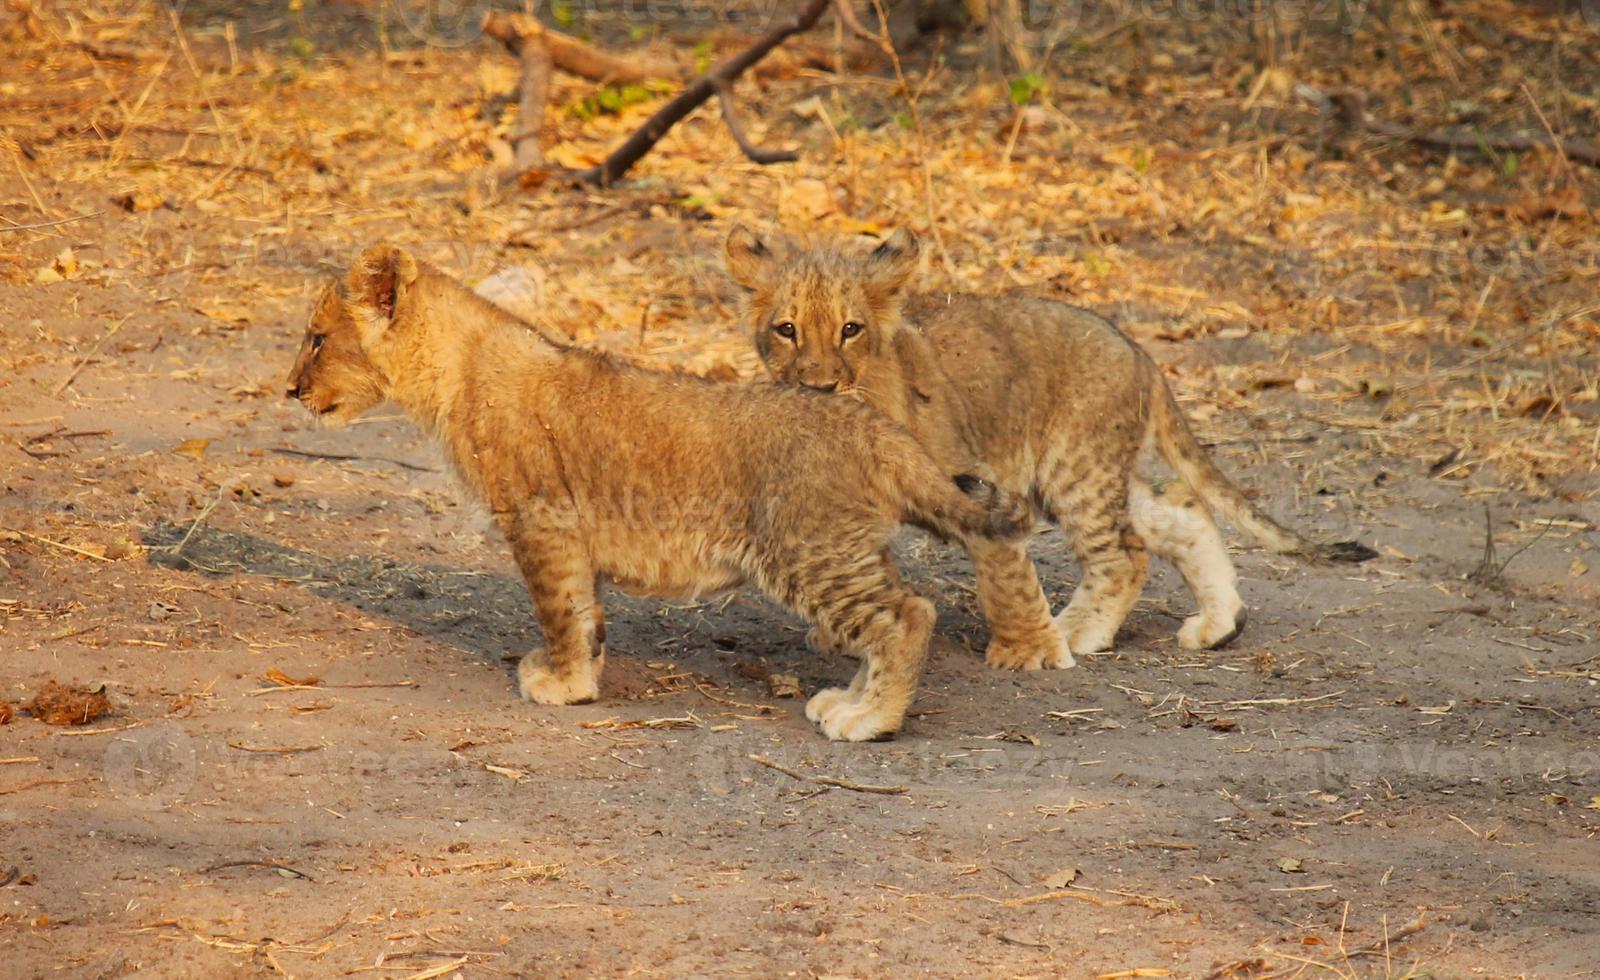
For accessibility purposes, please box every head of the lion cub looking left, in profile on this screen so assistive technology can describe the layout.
[286,245,418,426]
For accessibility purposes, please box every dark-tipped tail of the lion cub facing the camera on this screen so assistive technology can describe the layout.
[1146,360,1378,562]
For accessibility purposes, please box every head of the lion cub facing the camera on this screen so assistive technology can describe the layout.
[726,226,920,391]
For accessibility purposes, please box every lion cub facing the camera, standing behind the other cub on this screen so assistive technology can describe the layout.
[726,227,1373,669]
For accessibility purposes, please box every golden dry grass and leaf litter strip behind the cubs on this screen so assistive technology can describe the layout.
[0,2,1600,500]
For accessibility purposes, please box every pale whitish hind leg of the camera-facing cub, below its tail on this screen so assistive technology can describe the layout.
[1128,476,1245,650]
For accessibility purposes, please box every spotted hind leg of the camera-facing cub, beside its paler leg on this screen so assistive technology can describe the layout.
[1045,471,1150,653]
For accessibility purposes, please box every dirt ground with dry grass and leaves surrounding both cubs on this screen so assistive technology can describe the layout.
[0,0,1600,978]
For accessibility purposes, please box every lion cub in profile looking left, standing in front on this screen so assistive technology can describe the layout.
[288,245,1032,741]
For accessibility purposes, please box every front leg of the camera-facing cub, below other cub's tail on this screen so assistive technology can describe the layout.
[966,541,1074,671]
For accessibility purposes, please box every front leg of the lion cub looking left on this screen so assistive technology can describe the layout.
[510,533,605,705]
